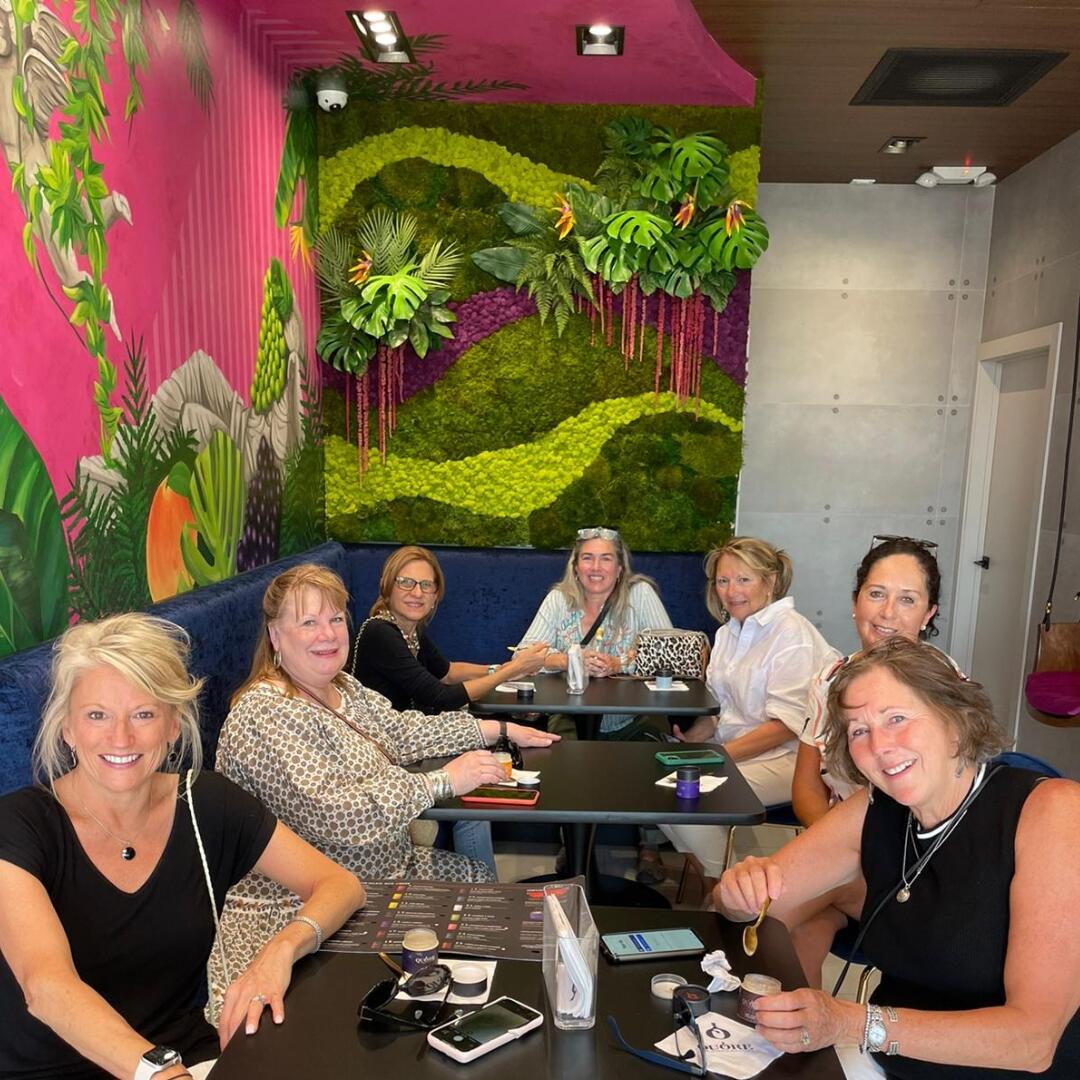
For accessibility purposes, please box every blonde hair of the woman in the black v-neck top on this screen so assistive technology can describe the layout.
[31,611,205,787]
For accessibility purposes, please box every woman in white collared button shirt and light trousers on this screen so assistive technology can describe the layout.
[661,537,839,878]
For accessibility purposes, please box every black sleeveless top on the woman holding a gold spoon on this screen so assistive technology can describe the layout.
[862,766,1080,1080]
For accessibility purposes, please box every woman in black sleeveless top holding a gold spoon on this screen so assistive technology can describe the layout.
[715,638,1080,1080]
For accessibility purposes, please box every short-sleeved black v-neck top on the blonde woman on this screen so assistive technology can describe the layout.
[0,772,276,1080]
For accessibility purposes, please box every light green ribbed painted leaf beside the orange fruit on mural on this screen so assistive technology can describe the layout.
[180,431,247,585]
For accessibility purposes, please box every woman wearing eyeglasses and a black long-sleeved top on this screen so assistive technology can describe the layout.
[349,544,548,873]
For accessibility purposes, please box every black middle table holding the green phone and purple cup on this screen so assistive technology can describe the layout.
[421,740,765,904]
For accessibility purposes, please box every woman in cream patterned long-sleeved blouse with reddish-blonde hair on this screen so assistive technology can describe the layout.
[212,563,557,1002]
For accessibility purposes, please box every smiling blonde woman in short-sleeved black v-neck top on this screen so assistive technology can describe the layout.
[0,613,364,1080]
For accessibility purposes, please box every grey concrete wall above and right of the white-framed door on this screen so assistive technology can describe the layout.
[983,132,1080,777]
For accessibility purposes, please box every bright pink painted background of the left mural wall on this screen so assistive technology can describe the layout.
[0,0,318,495]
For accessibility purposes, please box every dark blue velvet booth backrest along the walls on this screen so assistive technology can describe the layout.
[0,542,715,793]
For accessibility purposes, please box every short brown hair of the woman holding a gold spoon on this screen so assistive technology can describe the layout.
[825,634,1010,784]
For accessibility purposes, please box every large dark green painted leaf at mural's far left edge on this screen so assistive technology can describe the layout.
[0,401,69,656]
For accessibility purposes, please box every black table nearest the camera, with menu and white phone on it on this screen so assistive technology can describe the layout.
[214,907,843,1080]
